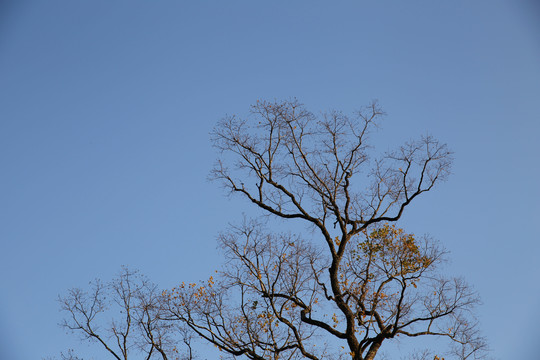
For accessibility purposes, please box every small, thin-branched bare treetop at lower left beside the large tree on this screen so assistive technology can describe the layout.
[59,267,193,360]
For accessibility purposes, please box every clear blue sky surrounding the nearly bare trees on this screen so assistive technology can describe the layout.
[0,0,540,360]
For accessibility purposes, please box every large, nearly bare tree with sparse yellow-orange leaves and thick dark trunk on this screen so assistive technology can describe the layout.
[166,100,485,360]
